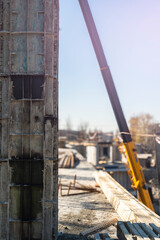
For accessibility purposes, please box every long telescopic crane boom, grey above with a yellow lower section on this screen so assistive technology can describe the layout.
[79,0,154,211]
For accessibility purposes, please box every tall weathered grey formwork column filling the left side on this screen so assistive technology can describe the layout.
[0,0,59,240]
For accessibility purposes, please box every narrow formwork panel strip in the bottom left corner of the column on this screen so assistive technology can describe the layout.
[0,204,8,240]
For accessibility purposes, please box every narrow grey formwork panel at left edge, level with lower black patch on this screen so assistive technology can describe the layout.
[0,162,8,202]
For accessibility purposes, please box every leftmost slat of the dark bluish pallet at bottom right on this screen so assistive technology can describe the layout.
[117,221,133,240]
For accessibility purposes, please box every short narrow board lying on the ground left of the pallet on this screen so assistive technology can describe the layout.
[80,218,117,236]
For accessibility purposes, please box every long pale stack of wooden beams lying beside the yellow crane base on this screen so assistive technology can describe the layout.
[94,171,160,227]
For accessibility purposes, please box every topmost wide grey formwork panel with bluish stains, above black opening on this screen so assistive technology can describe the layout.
[11,0,44,74]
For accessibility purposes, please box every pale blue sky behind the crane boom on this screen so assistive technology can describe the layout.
[59,0,160,131]
